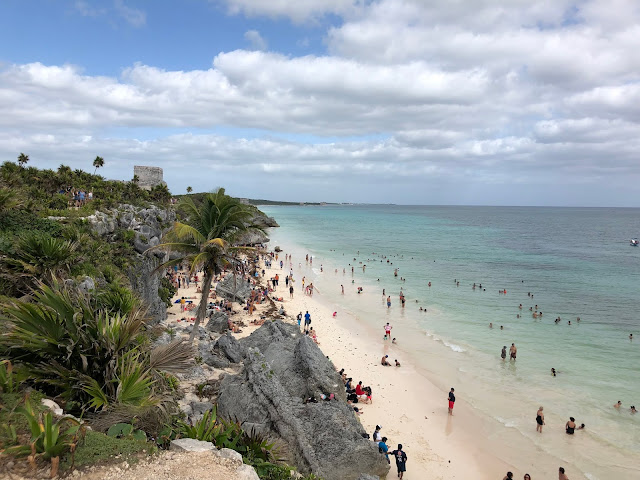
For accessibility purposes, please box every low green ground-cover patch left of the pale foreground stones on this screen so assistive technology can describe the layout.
[60,430,155,469]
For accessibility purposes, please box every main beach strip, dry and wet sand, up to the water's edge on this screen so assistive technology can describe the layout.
[266,239,600,480]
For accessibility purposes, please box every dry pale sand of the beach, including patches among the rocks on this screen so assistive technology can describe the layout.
[166,262,522,480]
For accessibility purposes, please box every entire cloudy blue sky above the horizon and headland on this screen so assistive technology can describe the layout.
[0,0,640,207]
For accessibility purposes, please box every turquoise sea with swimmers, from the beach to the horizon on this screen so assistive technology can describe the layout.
[261,205,640,479]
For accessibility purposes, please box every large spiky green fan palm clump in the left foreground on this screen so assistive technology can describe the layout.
[0,282,193,409]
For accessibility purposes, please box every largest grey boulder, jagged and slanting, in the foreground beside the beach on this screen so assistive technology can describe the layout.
[218,321,389,480]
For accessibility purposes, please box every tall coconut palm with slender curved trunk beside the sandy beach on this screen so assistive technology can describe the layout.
[147,188,262,342]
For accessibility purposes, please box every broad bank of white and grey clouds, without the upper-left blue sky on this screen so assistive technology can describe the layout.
[0,0,640,204]
